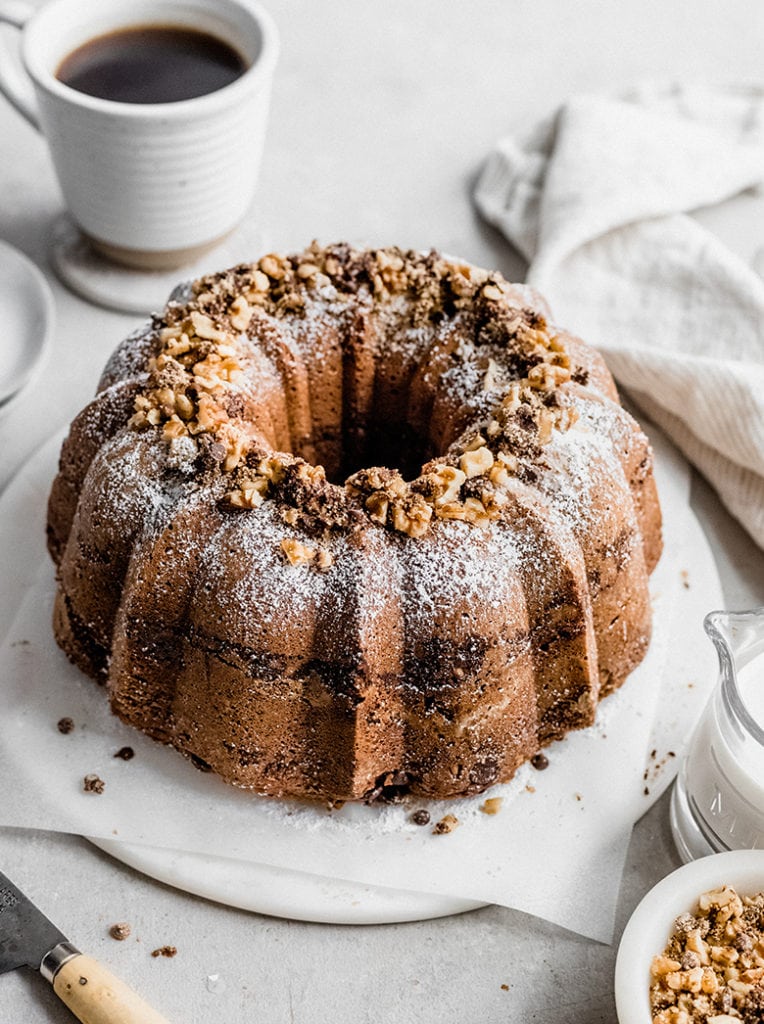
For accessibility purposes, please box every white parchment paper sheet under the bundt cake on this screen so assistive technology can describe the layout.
[0,428,716,941]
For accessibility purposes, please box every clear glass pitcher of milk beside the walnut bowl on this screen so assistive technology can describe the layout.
[671,607,764,861]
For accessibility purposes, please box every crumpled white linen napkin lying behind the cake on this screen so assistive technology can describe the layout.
[475,85,764,547]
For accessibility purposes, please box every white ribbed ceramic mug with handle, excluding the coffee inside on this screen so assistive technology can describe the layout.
[0,0,279,269]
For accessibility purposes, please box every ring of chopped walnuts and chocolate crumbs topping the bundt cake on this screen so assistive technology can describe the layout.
[130,243,585,540]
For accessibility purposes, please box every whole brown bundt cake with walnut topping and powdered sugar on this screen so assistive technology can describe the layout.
[48,244,662,801]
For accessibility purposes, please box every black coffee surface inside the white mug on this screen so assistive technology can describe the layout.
[55,25,247,103]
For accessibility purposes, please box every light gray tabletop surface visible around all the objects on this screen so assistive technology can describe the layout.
[0,0,764,1024]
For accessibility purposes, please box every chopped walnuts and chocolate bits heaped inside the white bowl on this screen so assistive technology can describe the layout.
[650,886,764,1024]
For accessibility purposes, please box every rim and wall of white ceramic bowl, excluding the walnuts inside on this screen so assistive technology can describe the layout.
[616,850,764,1024]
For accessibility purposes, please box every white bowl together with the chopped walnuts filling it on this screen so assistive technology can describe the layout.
[616,850,764,1024]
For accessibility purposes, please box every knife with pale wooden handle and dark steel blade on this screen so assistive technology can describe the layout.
[0,871,168,1024]
